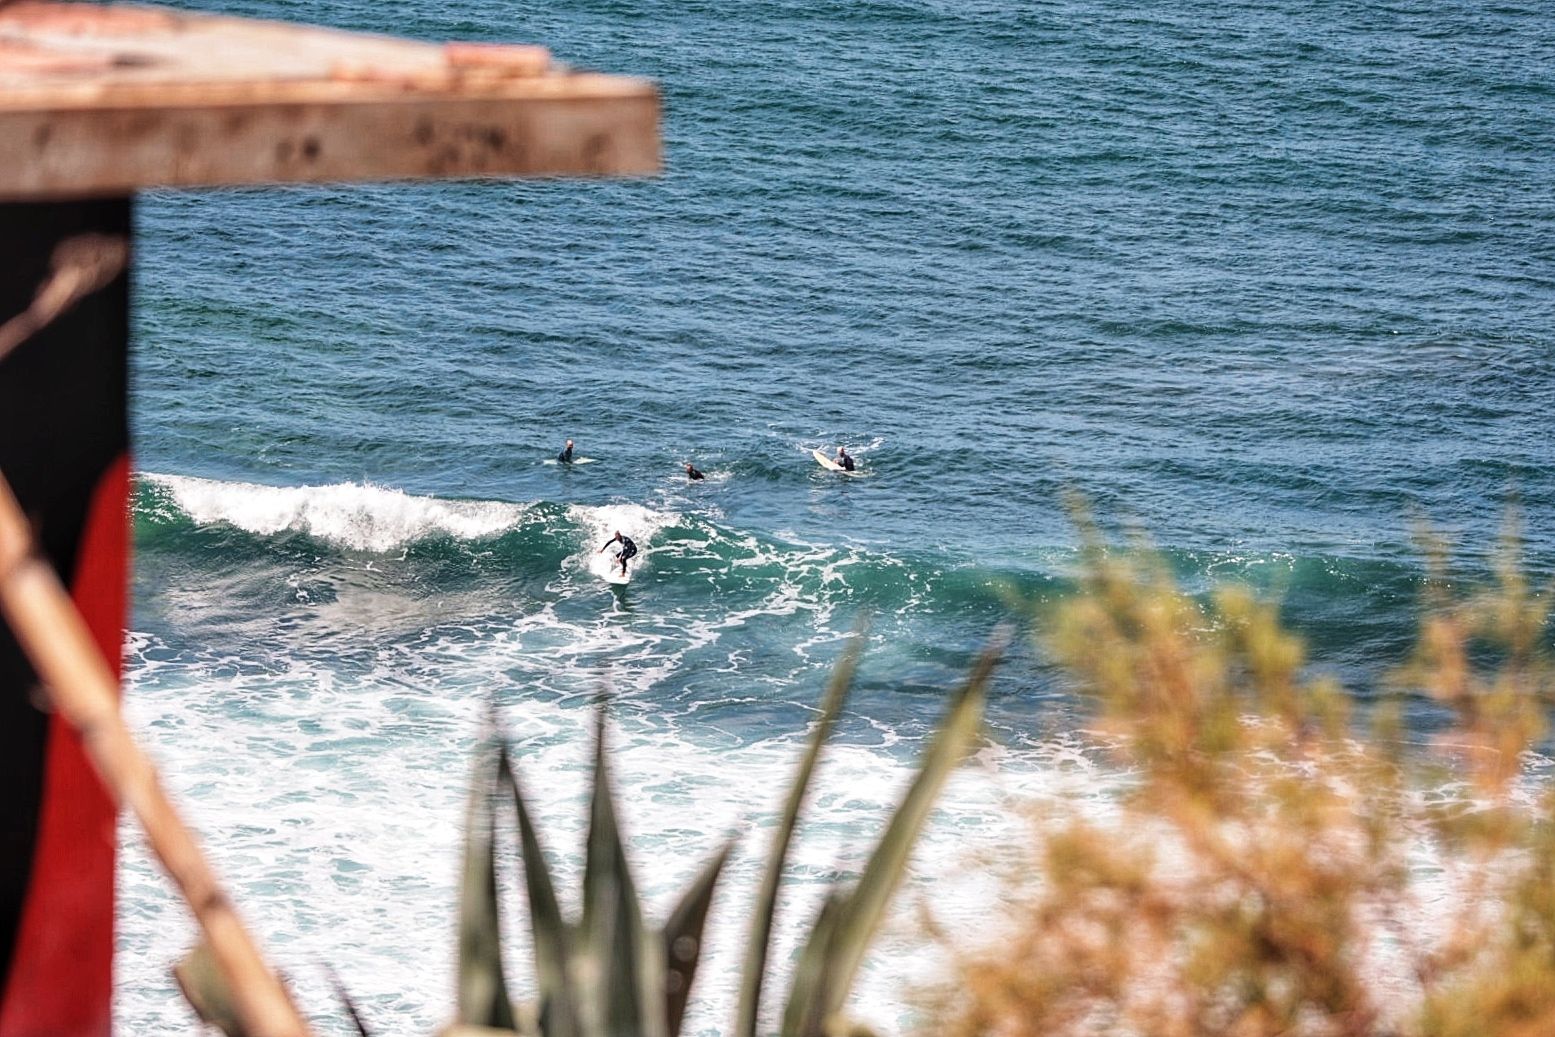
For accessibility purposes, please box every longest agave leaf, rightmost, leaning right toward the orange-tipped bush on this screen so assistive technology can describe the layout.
[784,630,1009,1037]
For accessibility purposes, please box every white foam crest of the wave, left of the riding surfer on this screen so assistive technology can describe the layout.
[142,473,527,552]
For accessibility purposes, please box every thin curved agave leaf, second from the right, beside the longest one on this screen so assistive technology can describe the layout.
[734,622,868,1037]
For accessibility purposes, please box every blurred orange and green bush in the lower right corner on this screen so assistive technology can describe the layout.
[922,522,1555,1037]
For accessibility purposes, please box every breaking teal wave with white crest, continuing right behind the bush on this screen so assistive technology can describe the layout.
[135,474,1421,702]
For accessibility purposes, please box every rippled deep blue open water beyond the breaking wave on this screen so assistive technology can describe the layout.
[137,3,1555,603]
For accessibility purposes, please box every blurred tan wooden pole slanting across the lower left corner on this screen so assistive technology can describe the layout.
[0,474,311,1037]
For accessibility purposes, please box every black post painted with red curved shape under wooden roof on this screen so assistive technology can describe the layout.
[0,196,132,1037]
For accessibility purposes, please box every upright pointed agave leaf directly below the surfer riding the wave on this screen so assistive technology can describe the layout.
[582,706,664,1037]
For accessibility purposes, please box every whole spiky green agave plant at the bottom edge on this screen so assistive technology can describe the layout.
[176,634,1006,1037]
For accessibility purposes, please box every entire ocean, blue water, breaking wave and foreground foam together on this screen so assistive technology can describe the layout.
[117,0,1555,1034]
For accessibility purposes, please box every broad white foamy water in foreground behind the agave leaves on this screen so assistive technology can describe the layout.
[118,619,1104,1037]
